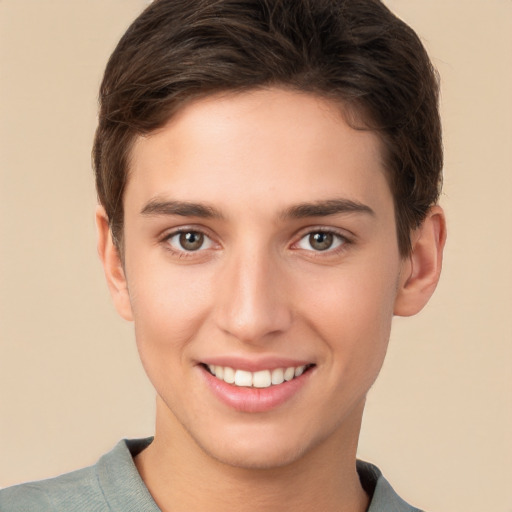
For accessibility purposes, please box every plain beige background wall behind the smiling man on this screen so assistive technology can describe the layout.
[0,0,512,512]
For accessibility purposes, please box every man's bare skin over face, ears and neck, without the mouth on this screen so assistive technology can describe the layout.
[97,89,445,511]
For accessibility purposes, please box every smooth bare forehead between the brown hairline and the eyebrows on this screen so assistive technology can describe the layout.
[125,89,390,215]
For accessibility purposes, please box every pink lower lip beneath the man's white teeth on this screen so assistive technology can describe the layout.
[199,366,312,412]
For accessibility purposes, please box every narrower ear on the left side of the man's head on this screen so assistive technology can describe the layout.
[96,206,133,321]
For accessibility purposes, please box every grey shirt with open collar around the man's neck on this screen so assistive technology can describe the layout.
[0,438,421,512]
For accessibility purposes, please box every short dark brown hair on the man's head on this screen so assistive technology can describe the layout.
[93,0,443,256]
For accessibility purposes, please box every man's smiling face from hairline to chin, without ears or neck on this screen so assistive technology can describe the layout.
[111,89,403,467]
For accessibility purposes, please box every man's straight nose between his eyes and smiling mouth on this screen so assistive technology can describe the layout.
[215,244,293,344]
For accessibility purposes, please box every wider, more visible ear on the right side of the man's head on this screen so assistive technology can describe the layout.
[394,205,446,316]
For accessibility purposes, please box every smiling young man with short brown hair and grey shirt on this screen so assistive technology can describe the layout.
[0,0,445,512]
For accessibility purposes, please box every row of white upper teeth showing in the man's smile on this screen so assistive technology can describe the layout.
[208,365,306,388]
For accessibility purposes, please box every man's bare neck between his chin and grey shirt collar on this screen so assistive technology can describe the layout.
[135,398,368,512]
